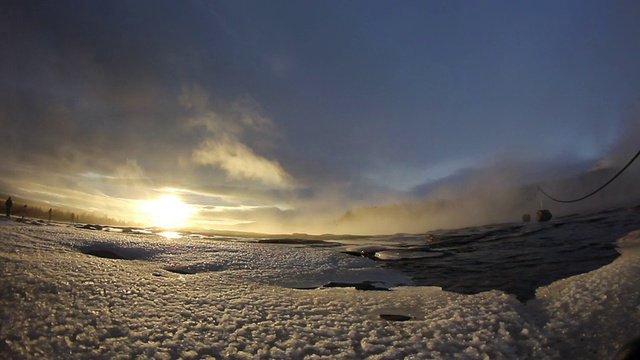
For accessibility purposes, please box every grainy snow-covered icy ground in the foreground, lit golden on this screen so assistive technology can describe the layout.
[0,219,640,359]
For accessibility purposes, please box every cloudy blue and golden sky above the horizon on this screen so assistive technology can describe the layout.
[0,0,640,233]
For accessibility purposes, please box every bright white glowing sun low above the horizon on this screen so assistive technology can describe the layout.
[141,195,193,229]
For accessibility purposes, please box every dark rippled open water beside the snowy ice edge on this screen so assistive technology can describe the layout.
[349,208,640,301]
